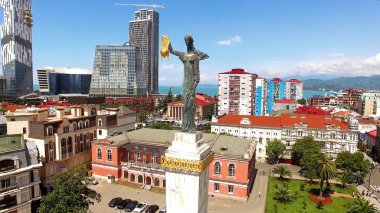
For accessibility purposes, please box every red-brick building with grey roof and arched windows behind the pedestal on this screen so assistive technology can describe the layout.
[92,128,255,200]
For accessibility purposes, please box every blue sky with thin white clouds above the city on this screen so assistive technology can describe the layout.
[0,0,380,86]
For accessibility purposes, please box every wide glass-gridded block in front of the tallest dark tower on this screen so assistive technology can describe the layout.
[90,44,146,98]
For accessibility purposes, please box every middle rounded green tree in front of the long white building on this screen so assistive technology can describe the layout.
[292,136,321,162]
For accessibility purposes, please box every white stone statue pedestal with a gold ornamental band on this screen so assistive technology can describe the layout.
[162,132,214,213]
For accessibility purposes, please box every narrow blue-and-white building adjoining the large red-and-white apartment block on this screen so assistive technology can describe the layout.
[253,76,267,115]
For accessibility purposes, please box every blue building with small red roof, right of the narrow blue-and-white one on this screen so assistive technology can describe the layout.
[267,78,285,115]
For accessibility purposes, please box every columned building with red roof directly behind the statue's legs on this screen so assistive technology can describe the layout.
[164,93,217,123]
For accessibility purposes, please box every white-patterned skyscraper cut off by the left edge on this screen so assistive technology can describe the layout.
[0,0,33,96]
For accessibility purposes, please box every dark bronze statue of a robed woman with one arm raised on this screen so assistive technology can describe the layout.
[163,35,208,132]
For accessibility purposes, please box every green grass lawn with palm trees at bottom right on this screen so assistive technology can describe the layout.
[265,177,357,213]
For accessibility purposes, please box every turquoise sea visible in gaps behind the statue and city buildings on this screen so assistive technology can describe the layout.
[158,84,335,99]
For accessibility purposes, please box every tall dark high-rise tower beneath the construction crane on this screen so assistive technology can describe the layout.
[129,9,159,93]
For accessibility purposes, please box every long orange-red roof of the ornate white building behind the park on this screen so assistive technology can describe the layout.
[217,114,349,130]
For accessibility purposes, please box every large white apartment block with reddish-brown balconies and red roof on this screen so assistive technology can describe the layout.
[218,69,255,115]
